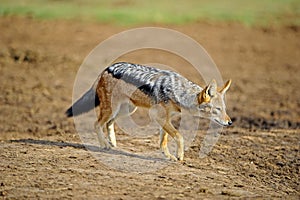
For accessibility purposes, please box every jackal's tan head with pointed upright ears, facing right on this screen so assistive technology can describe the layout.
[198,80,232,126]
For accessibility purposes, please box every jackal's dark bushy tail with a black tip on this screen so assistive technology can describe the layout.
[65,87,100,117]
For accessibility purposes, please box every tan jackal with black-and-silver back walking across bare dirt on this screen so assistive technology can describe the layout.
[66,62,232,161]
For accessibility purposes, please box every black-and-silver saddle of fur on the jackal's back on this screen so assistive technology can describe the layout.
[106,62,202,108]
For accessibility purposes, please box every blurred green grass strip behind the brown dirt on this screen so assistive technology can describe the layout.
[0,0,300,26]
